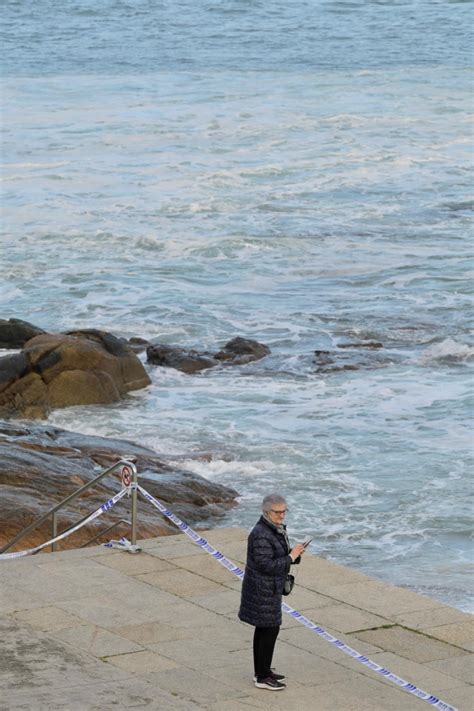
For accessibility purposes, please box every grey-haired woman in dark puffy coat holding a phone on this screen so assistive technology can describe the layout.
[239,494,305,691]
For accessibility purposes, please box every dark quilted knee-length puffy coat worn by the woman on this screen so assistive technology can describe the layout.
[239,516,292,627]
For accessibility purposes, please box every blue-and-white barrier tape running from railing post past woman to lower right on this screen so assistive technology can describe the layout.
[138,486,458,711]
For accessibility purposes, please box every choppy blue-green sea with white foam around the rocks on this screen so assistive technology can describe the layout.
[0,0,474,609]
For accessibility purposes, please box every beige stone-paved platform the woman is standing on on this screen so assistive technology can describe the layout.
[0,528,474,711]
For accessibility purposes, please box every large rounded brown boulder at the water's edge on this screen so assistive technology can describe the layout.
[0,330,150,418]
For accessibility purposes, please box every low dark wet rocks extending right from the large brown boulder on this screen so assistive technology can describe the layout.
[146,336,270,373]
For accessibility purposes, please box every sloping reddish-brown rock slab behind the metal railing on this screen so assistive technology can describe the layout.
[0,422,238,550]
